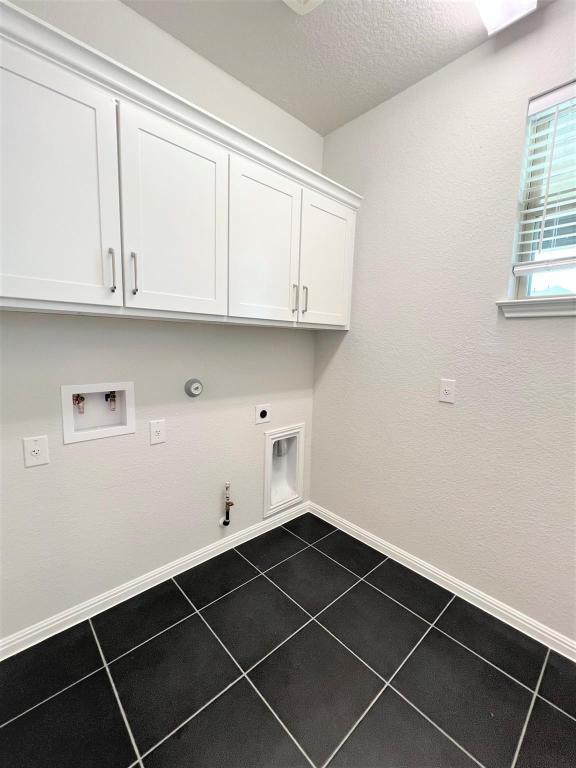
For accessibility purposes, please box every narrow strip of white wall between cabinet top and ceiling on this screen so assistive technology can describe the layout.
[14,0,323,170]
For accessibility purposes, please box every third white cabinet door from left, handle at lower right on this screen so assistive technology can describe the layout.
[230,155,301,320]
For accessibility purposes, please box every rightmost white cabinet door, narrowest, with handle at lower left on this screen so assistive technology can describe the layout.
[299,189,356,325]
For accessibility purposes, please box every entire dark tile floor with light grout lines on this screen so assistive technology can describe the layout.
[0,515,576,768]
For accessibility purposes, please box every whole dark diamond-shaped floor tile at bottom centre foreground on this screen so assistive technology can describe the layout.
[250,623,382,765]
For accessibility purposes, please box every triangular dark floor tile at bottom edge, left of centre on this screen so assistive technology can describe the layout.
[144,680,309,768]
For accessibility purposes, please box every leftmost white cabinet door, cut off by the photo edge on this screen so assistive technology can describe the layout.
[0,42,122,305]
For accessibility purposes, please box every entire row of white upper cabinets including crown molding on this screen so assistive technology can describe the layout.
[0,6,360,328]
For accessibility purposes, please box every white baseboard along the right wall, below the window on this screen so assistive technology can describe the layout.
[308,502,576,661]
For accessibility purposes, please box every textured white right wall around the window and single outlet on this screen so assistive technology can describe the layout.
[312,0,576,637]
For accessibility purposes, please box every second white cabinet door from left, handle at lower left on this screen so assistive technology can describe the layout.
[120,104,228,315]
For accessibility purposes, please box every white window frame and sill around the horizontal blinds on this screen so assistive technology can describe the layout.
[496,81,576,317]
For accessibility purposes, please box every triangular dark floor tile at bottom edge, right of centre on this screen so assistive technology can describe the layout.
[330,688,477,768]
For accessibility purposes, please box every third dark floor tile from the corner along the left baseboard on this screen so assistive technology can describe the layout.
[175,549,258,608]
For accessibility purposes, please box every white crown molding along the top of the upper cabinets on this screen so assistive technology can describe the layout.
[0,0,362,210]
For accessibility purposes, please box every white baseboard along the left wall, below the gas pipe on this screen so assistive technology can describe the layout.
[0,502,308,660]
